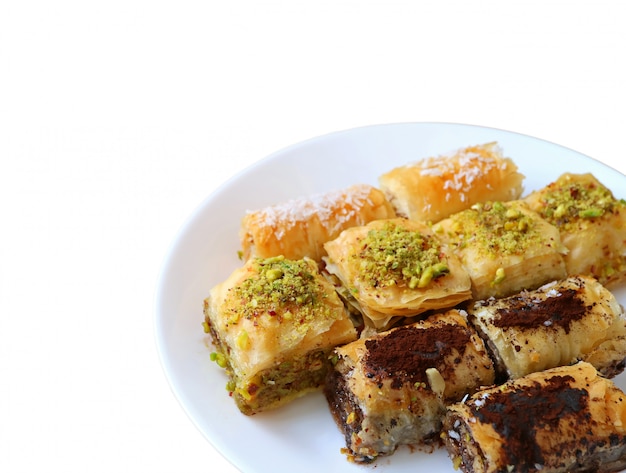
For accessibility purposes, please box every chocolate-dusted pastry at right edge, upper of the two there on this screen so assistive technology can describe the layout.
[468,276,626,378]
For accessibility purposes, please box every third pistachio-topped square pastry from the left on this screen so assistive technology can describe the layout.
[433,200,566,299]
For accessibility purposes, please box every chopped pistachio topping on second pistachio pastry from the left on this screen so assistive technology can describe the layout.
[354,222,449,289]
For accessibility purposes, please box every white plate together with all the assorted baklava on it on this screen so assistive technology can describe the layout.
[155,123,626,473]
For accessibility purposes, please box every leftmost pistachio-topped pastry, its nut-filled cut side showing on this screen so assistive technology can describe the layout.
[204,257,357,415]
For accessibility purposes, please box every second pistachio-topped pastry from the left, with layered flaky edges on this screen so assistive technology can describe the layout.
[324,218,471,330]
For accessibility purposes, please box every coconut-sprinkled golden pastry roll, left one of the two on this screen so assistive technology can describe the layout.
[239,184,395,262]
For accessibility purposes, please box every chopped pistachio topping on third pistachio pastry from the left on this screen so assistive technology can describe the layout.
[452,202,541,256]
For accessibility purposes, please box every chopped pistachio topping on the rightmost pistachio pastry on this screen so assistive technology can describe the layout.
[539,182,624,228]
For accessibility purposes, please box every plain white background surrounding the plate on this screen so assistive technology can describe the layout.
[0,0,626,472]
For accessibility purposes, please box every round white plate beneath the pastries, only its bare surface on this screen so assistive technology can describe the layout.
[155,123,626,473]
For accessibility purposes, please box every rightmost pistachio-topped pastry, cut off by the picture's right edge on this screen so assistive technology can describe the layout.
[525,173,626,285]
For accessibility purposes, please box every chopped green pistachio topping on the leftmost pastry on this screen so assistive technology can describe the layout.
[228,256,330,326]
